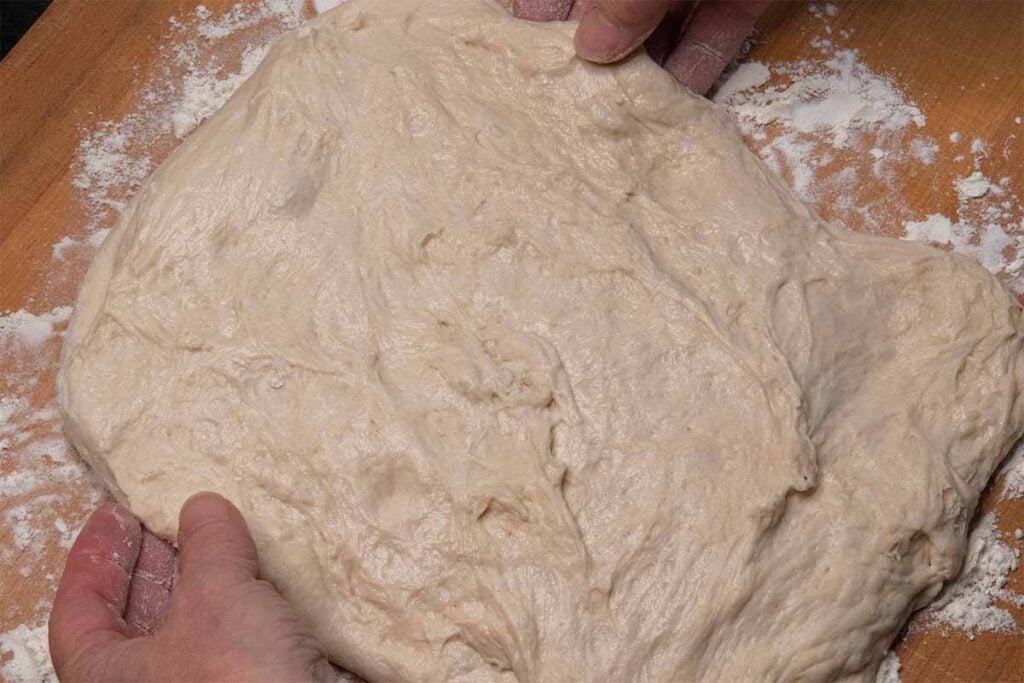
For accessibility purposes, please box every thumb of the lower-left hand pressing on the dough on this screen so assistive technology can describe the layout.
[178,493,257,588]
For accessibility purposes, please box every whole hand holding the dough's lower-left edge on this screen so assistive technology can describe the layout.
[50,494,336,683]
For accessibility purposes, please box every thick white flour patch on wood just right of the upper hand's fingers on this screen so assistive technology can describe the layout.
[714,43,938,231]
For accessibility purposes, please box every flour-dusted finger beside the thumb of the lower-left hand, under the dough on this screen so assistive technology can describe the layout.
[125,530,176,636]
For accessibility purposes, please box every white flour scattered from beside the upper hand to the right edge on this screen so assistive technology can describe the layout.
[714,5,1024,295]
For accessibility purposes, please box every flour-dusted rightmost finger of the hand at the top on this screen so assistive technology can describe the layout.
[663,0,768,94]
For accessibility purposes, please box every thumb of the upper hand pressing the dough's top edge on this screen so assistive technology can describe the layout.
[575,0,669,63]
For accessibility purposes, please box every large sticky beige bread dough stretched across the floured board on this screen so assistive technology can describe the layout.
[61,0,1024,681]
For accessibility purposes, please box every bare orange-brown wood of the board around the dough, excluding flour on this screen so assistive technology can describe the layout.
[0,0,1024,681]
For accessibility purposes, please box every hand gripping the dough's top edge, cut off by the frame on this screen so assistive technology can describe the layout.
[512,0,768,94]
